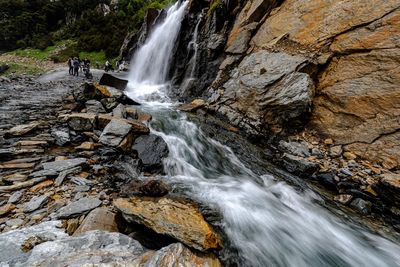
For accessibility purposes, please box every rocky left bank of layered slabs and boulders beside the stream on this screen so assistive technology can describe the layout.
[0,70,222,266]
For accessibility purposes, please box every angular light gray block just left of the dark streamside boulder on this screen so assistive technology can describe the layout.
[99,119,132,147]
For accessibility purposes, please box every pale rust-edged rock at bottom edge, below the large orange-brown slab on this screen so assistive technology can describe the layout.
[146,243,222,267]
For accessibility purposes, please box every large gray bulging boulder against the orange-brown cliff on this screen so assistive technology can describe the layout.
[214,51,314,134]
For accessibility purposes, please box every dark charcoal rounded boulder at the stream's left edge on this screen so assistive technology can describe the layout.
[132,134,169,173]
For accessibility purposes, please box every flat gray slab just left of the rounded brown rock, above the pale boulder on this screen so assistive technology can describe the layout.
[55,197,101,219]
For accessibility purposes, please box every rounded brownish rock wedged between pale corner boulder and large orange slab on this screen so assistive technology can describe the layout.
[74,208,118,236]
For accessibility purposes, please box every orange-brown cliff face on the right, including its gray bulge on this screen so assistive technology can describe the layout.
[208,0,400,166]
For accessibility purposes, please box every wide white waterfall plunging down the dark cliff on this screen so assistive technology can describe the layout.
[128,1,188,99]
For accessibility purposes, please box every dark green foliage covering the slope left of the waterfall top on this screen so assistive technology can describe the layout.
[0,0,175,59]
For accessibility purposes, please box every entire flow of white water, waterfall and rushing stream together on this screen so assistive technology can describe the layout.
[129,3,400,267]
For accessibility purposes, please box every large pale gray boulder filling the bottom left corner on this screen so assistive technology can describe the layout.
[0,221,146,267]
